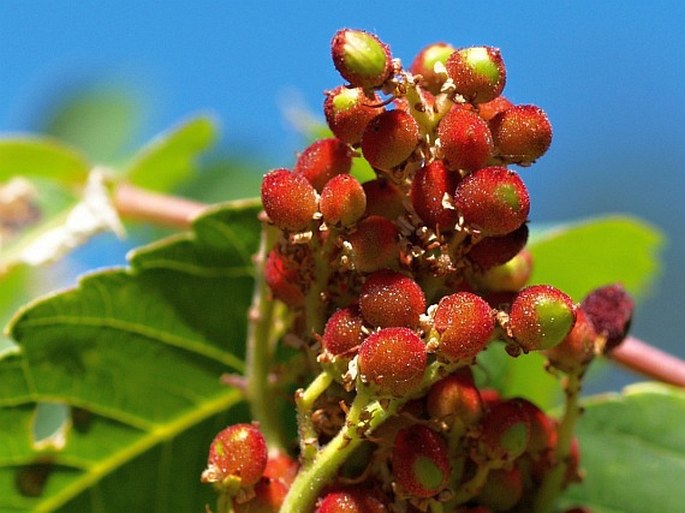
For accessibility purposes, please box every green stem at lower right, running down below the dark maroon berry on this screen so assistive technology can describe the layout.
[533,374,581,513]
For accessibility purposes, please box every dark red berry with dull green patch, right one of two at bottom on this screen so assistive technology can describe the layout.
[478,399,531,463]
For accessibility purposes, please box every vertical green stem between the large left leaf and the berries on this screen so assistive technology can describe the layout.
[245,226,287,449]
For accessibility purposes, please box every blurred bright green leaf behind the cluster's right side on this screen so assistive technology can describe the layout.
[529,216,663,301]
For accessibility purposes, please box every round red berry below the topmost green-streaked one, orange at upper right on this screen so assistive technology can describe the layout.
[362,109,419,171]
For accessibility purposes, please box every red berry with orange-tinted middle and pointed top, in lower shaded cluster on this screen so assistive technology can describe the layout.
[426,367,483,427]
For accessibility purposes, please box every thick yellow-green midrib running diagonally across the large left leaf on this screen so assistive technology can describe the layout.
[34,390,241,513]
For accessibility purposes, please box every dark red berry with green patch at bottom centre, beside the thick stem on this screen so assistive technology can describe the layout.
[391,424,450,498]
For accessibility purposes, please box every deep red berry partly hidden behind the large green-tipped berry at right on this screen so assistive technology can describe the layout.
[410,160,459,232]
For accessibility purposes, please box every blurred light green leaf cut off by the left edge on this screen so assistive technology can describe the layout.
[0,136,90,185]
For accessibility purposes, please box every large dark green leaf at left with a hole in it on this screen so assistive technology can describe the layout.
[0,202,260,513]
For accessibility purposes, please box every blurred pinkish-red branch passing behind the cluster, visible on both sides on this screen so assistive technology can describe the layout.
[114,184,685,387]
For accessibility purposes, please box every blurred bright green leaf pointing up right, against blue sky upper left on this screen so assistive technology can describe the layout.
[125,116,216,191]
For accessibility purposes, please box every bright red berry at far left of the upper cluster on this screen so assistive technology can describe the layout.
[262,169,318,232]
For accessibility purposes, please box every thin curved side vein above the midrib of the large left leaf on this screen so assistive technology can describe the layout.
[14,315,245,372]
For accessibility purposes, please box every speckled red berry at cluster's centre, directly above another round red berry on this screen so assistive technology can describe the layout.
[359,271,426,328]
